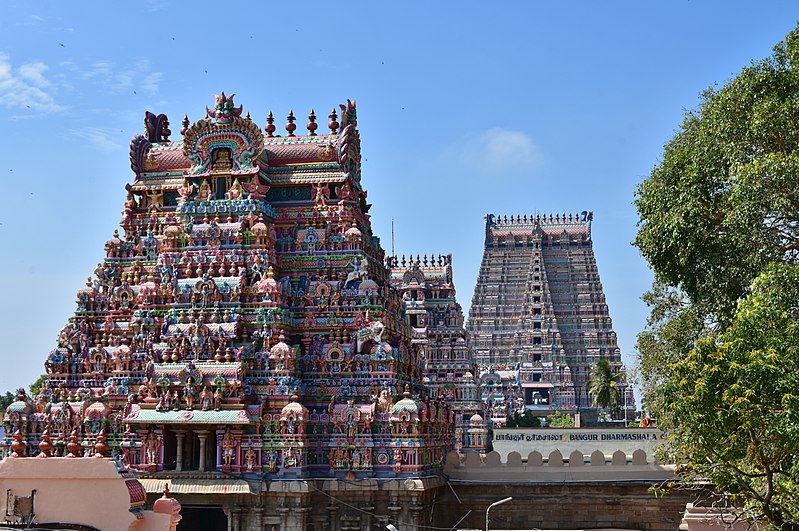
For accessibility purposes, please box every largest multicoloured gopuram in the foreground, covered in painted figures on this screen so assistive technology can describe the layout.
[4,93,462,490]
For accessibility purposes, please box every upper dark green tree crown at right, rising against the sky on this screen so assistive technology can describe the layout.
[635,30,799,323]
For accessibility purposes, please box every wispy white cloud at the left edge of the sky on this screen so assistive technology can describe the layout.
[0,52,64,113]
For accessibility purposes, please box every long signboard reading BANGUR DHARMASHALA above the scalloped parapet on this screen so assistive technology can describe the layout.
[493,428,663,461]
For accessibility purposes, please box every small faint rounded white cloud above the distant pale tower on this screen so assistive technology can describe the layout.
[450,127,541,172]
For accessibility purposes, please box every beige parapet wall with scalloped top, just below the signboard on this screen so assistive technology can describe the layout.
[444,450,674,483]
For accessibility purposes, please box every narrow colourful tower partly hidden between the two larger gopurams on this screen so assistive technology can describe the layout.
[390,254,487,452]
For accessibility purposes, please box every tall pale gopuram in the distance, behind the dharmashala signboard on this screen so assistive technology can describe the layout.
[467,212,635,424]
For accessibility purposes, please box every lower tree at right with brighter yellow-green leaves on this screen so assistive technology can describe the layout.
[659,264,799,530]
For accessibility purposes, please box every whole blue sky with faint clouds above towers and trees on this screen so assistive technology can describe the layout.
[0,0,799,391]
